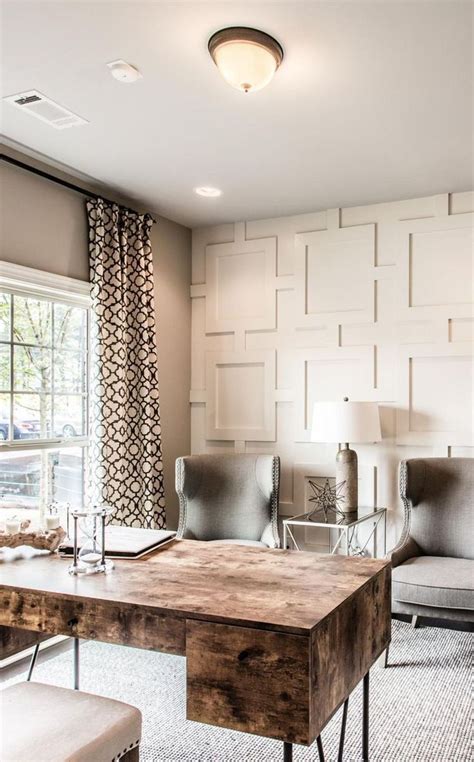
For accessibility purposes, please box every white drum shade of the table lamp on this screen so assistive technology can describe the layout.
[311,402,382,443]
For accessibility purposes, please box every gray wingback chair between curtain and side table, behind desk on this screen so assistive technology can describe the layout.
[176,455,280,548]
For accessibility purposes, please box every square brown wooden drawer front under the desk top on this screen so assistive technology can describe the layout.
[186,619,310,744]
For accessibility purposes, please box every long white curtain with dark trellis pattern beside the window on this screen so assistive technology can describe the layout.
[87,199,165,528]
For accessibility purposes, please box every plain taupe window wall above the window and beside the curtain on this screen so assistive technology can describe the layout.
[0,149,191,527]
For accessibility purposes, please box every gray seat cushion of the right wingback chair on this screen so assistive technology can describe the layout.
[392,556,474,610]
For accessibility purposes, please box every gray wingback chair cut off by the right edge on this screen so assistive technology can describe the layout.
[390,458,474,625]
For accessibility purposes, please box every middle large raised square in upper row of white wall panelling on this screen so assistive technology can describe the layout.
[295,225,375,328]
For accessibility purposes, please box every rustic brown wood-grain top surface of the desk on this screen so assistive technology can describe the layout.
[0,540,389,635]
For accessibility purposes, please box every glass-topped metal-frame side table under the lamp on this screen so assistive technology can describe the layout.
[283,506,387,558]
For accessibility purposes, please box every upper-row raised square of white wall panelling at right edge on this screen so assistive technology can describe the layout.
[397,214,474,320]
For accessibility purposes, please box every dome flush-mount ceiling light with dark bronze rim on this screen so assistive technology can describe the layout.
[208,26,283,93]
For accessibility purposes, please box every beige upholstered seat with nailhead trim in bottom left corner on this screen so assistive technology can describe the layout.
[0,682,142,762]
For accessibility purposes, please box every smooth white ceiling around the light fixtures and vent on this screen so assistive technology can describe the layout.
[2,0,472,226]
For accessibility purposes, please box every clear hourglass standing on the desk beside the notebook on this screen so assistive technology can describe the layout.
[69,505,114,574]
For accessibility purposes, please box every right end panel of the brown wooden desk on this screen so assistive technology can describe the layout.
[311,566,391,741]
